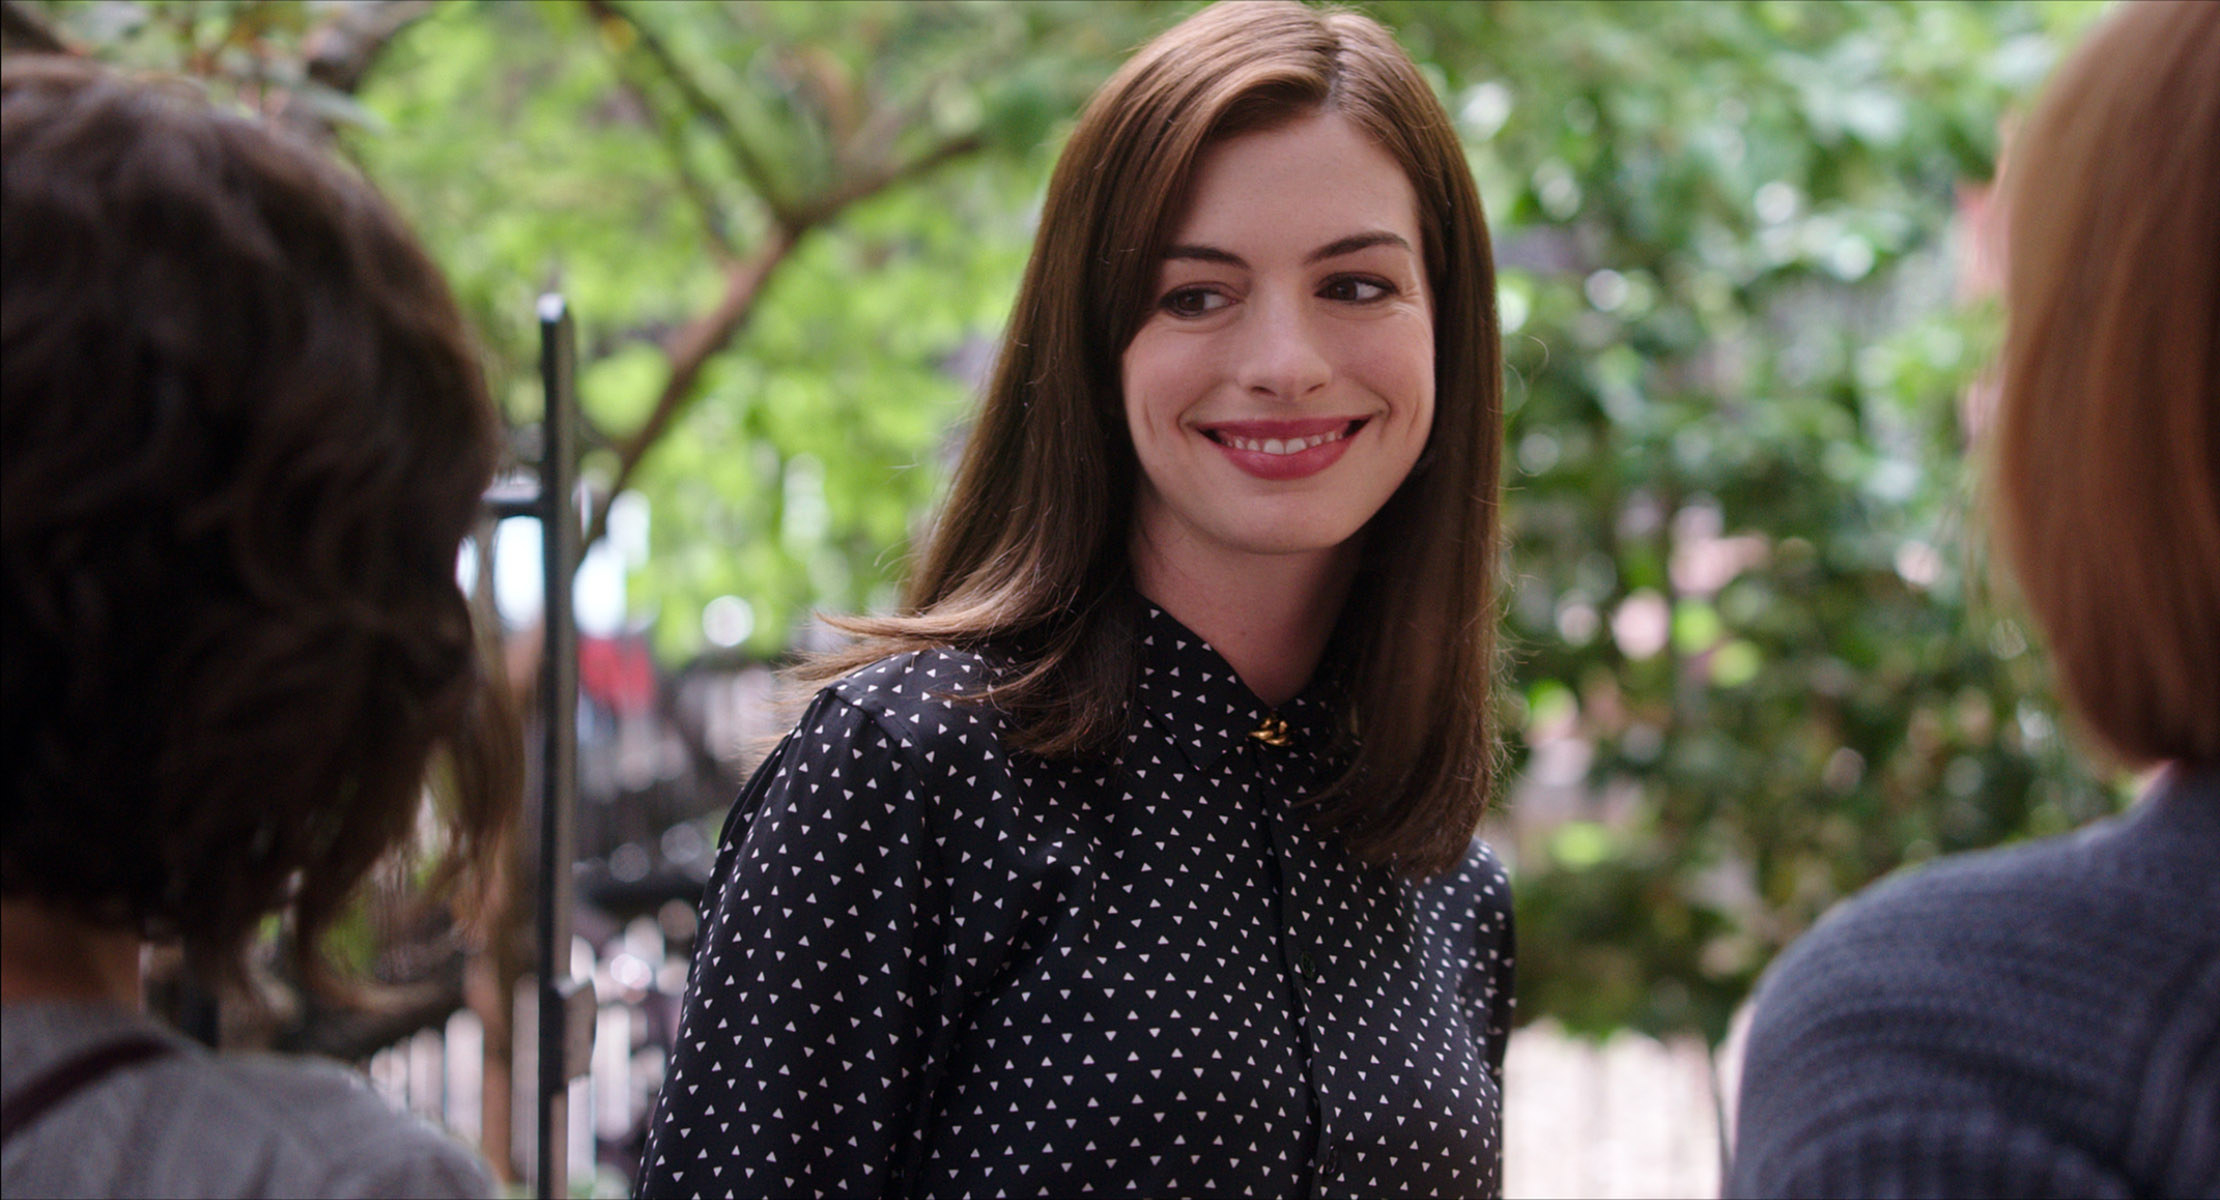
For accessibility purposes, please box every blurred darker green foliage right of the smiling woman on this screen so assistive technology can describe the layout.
[1376,2,2116,1038]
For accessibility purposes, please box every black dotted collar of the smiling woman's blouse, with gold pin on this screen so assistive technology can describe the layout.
[1137,597,1336,770]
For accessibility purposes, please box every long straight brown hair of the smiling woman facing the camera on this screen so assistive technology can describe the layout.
[813,0,1503,876]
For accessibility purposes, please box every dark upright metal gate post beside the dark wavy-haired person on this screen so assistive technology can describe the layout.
[533,293,582,1200]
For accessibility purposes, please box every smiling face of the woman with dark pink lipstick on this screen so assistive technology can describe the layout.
[1121,113,1434,581]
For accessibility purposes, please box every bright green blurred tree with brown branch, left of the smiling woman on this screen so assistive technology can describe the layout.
[353,0,1139,659]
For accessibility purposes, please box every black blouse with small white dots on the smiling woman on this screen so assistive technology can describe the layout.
[639,608,1512,1196]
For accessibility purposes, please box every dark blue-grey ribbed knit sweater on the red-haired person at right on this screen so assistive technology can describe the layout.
[1727,767,2220,1198]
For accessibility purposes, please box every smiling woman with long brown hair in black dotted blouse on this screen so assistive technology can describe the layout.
[639,2,1512,1196]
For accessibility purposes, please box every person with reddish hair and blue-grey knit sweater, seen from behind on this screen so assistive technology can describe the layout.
[1727,2,2220,1198]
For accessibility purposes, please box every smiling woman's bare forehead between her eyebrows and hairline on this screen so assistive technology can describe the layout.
[1172,113,1421,257]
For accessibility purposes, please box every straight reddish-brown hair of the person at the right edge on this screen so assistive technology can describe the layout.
[1989,2,2220,765]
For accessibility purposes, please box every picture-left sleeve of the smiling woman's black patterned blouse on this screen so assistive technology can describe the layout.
[639,692,946,1196]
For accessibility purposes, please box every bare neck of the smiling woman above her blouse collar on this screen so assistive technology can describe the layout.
[1130,530,1356,705]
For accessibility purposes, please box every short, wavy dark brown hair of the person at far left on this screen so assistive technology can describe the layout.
[0,58,519,989]
